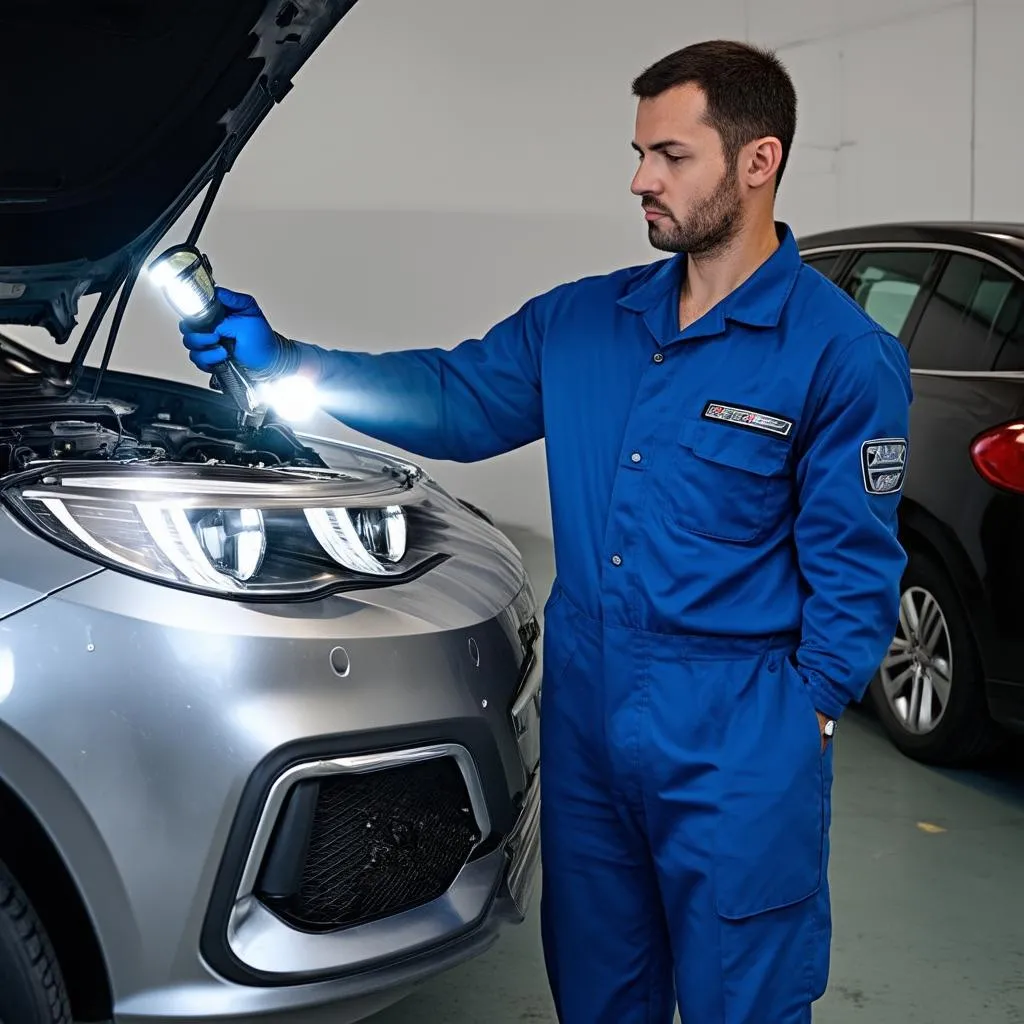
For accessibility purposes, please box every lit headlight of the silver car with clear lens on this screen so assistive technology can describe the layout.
[3,463,444,600]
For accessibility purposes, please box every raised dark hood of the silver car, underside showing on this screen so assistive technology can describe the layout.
[0,0,356,343]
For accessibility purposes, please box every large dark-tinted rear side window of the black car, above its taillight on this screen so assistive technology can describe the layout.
[910,253,1024,372]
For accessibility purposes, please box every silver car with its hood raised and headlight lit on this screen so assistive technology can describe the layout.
[0,0,541,1024]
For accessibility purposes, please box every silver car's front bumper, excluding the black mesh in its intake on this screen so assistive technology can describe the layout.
[0,544,540,1024]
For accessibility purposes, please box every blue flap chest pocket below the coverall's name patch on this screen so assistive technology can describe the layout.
[671,420,792,544]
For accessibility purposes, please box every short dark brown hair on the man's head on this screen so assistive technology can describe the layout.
[633,39,797,190]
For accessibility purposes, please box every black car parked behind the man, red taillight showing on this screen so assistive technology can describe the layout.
[800,222,1024,765]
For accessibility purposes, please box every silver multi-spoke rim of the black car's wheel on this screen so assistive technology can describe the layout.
[881,587,952,735]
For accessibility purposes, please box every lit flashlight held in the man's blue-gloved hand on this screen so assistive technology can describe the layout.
[148,245,262,426]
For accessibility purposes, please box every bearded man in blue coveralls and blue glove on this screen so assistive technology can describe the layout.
[178,41,911,1024]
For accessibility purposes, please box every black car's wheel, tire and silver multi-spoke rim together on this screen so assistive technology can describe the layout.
[869,550,1005,767]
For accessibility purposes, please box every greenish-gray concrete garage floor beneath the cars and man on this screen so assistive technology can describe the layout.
[374,528,1024,1024]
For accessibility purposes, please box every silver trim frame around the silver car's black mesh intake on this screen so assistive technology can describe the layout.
[227,743,497,975]
